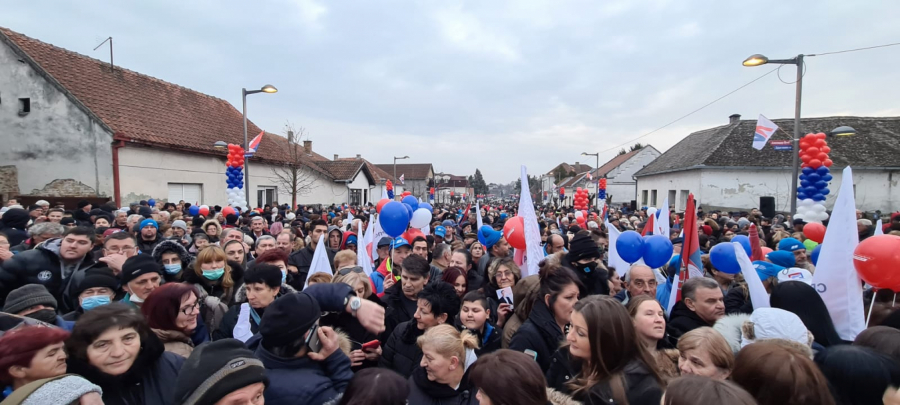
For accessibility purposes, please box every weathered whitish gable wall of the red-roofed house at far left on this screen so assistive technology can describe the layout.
[0,42,113,196]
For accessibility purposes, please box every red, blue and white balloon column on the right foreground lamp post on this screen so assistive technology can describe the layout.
[795,132,832,222]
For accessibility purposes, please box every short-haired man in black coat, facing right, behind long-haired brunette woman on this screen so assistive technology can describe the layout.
[666,277,725,344]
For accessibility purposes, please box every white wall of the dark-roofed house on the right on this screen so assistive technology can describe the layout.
[638,169,900,213]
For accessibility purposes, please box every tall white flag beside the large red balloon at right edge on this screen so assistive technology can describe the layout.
[813,166,866,341]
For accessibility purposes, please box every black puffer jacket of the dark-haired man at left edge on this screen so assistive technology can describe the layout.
[0,239,97,314]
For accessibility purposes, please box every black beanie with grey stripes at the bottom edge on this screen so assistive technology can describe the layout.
[175,339,269,405]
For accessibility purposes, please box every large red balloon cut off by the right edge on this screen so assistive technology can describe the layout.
[853,235,900,291]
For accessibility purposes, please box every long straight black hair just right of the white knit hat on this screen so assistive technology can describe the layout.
[769,281,844,347]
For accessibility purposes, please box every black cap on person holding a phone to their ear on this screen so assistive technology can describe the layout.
[259,292,322,347]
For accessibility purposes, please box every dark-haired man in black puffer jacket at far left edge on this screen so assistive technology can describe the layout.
[0,227,96,313]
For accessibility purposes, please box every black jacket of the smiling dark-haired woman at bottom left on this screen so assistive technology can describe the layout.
[68,328,184,405]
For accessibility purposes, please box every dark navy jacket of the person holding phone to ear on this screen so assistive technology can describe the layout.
[256,345,353,405]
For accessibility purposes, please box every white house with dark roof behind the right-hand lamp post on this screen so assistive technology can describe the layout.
[635,114,900,212]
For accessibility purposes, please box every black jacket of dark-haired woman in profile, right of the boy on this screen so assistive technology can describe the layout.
[509,300,565,373]
